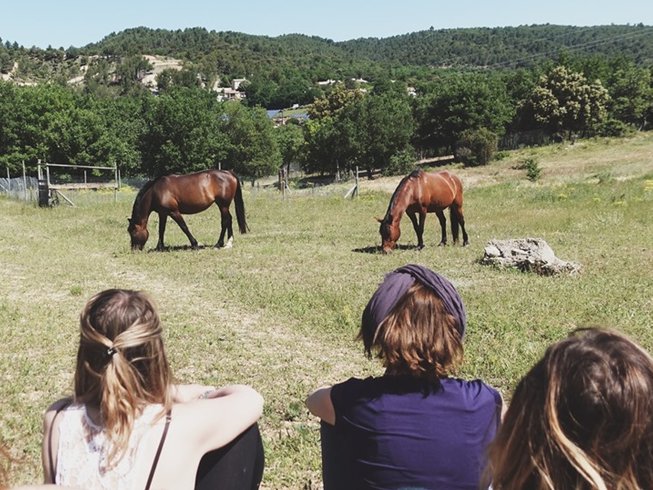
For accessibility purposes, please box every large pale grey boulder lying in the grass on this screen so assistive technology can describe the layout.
[481,238,580,276]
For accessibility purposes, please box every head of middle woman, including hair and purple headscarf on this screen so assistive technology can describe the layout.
[359,264,466,382]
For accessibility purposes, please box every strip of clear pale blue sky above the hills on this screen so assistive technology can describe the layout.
[0,0,653,48]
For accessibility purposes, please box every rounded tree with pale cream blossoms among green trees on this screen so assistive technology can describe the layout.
[526,66,609,137]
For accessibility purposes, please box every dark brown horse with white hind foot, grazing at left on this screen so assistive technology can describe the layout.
[127,170,248,250]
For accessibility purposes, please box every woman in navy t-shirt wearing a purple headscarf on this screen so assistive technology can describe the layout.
[306,264,502,490]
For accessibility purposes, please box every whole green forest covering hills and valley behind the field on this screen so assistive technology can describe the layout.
[0,25,653,180]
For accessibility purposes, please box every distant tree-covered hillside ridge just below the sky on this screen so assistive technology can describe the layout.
[0,24,653,90]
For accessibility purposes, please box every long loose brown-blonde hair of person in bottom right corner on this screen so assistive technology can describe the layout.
[487,329,653,490]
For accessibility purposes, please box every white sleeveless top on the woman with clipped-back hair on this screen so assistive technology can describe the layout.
[55,404,165,490]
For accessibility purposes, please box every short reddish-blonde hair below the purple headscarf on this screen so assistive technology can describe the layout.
[358,281,463,382]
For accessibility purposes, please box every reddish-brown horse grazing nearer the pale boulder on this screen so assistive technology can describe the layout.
[377,170,469,253]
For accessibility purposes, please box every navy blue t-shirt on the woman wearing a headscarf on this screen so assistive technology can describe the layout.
[331,376,501,490]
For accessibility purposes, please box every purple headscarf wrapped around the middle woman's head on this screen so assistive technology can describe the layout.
[362,264,467,339]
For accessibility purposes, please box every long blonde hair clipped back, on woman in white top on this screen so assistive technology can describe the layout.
[75,289,172,468]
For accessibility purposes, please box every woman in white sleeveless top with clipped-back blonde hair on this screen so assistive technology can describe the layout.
[43,289,263,490]
